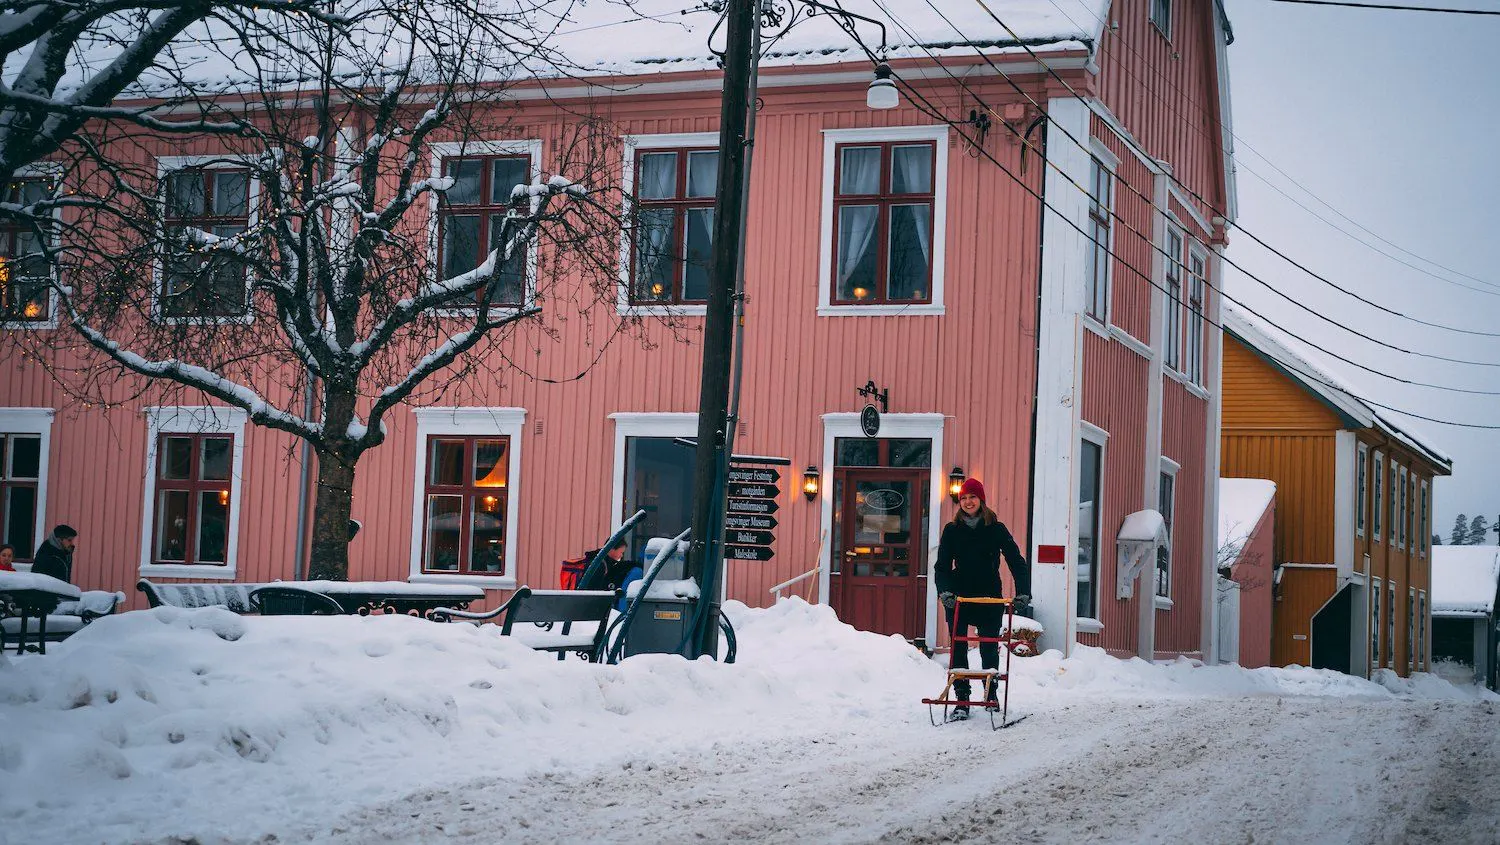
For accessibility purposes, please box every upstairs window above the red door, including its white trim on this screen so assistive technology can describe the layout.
[818,125,948,317]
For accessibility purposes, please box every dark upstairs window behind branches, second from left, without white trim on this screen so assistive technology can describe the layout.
[161,168,251,318]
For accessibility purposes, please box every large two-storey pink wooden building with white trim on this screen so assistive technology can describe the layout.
[0,0,1233,657]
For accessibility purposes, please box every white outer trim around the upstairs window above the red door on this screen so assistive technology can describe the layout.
[818,123,948,317]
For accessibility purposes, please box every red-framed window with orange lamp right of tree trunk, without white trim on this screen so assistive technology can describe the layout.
[422,435,510,575]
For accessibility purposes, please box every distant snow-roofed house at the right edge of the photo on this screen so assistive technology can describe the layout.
[1433,546,1500,689]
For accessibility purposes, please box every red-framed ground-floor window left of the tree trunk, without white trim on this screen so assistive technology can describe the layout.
[152,434,234,566]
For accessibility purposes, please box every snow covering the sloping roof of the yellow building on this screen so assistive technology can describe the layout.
[1223,305,1454,471]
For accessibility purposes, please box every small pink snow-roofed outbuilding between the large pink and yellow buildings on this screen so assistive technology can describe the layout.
[1215,479,1277,669]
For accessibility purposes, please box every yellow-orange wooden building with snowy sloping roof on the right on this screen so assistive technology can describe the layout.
[1220,306,1452,675]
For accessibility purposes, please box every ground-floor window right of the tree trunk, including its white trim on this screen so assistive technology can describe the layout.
[408,407,527,590]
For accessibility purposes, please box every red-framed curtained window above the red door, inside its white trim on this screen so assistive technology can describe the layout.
[833,143,938,305]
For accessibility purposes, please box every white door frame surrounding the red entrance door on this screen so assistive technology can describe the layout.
[818,413,948,642]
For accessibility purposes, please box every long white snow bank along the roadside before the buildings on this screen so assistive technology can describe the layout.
[0,599,1488,842]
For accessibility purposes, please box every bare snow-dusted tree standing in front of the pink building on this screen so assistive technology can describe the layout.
[13,0,645,578]
